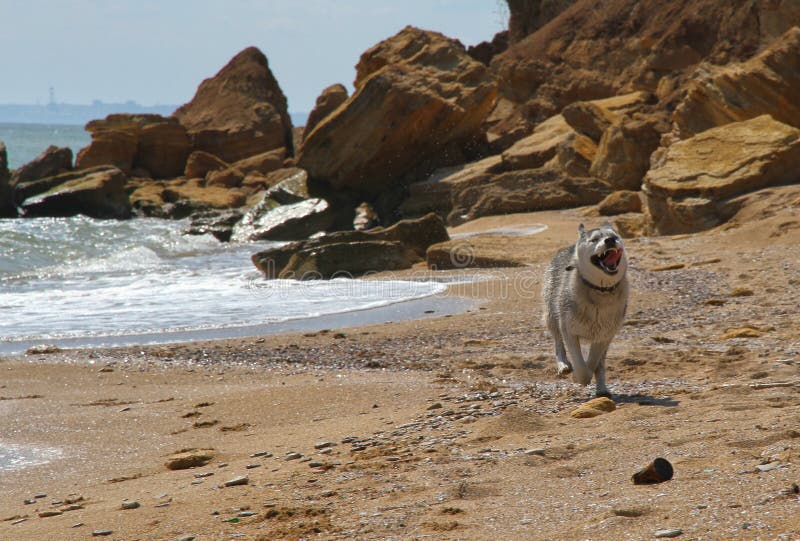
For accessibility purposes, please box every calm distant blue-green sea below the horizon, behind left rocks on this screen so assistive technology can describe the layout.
[0,122,91,169]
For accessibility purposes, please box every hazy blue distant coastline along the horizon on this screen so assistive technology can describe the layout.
[0,100,308,126]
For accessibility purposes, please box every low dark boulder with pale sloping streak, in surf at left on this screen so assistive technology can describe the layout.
[16,166,131,219]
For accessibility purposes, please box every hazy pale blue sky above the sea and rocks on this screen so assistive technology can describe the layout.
[0,0,507,112]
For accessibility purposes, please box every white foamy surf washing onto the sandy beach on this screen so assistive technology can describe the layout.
[0,216,447,354]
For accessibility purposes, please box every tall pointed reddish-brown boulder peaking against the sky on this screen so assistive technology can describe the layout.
[174,47,293,163]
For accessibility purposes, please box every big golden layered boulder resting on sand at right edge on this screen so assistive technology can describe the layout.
[642,115,800,234]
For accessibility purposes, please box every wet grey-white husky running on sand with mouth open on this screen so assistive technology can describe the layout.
[542,224,628,396]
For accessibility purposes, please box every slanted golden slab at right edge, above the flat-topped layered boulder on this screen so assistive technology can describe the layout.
[673,26,800,138]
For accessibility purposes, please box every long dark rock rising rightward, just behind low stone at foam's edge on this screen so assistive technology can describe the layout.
[251,213,450,278]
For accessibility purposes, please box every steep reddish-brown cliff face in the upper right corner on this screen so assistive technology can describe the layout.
[490,0,798,146]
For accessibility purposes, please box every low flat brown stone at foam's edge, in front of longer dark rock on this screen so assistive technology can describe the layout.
[280,240,421,280]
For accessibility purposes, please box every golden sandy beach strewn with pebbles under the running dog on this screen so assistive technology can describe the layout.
[0,192,800,540]
